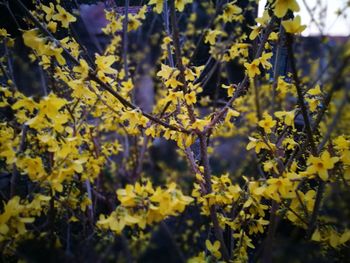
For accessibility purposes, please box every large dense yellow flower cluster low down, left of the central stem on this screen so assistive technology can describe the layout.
[97,180,193,234]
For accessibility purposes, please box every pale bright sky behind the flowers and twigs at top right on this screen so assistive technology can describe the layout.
[259,0,350,36]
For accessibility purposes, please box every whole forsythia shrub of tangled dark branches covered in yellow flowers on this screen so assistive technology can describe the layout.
[0,0,350,262]
